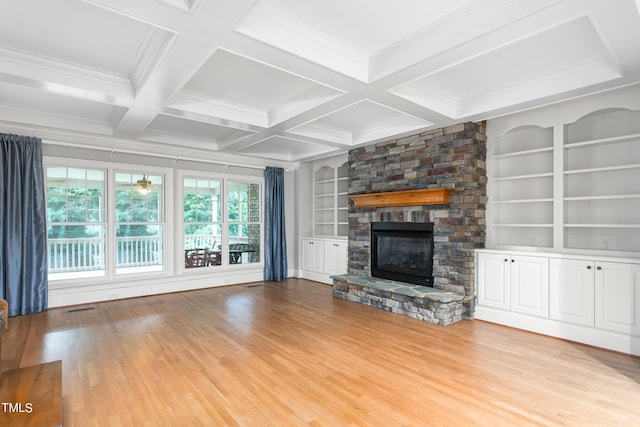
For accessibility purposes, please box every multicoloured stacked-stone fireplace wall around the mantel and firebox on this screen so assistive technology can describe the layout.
[348,122,487,319]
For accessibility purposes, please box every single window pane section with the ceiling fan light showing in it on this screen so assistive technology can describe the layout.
[114,172,164,274]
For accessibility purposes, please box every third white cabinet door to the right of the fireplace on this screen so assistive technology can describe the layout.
[549,259,595,326]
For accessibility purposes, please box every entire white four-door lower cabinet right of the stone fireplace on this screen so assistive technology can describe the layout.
[475,249,640,356]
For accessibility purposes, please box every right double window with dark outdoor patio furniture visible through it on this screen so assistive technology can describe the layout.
[183,177,262,269]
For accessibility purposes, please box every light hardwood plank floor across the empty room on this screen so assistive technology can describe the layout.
[2,279,640,427]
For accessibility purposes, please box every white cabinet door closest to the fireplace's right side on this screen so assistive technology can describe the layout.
[477,253,510,310]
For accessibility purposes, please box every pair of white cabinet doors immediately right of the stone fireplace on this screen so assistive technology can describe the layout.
[477,253,549,317]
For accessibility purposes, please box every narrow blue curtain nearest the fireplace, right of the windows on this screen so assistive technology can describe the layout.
[264,167,287,281]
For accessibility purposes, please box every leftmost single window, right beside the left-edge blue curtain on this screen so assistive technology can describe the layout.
[46,167,107,280]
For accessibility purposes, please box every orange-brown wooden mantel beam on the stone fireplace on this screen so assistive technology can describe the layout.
[349,188,453,208]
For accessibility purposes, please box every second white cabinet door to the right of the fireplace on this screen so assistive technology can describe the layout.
[509,256,549,318]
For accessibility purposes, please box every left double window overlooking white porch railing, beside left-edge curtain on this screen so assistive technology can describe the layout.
[46,165,165,281]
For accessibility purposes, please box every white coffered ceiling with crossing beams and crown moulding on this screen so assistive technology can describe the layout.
[0,0,640,164]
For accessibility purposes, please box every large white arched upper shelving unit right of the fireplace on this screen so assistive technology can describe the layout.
[487,88,640,256]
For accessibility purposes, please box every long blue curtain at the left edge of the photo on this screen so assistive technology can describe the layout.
[0,134,49,316]
